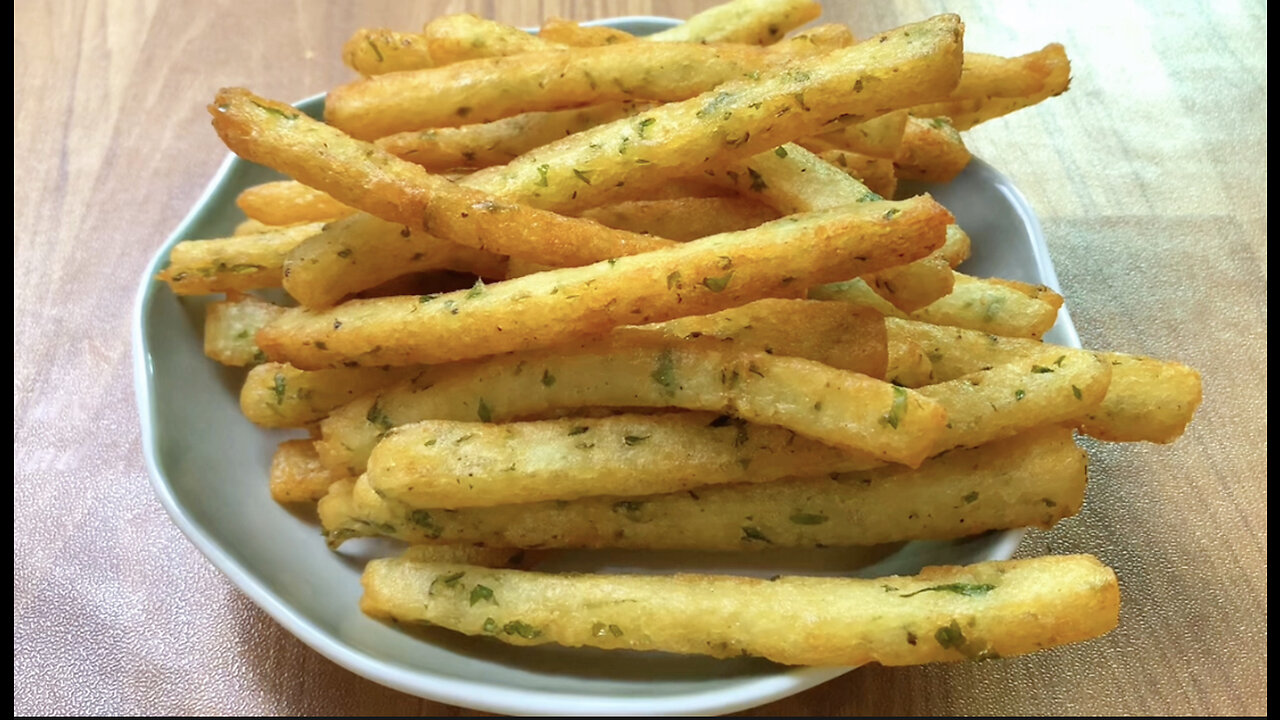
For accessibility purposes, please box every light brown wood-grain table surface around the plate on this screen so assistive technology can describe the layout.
[14,0,1267,715]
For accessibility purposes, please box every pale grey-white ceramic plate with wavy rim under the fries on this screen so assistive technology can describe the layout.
[133,18,1079,715]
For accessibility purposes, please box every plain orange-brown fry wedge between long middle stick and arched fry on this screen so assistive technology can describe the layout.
[622,299,888,378]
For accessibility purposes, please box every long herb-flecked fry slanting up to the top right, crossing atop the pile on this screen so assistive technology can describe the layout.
[466,15,963,211]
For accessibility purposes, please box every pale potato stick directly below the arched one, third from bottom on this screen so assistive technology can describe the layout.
[366,413,883,509]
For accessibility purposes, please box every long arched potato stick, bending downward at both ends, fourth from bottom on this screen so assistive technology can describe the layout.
[317,338,946,475]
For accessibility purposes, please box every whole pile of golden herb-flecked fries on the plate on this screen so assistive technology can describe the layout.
[160,0,1201,665]
